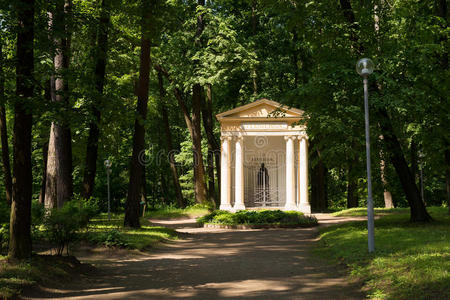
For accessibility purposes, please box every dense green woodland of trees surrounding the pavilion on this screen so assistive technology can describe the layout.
[0,0,450,258]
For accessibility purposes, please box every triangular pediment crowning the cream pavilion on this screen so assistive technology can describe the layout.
[216,99,303,120]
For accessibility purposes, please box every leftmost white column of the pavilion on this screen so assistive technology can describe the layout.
[220,136,232,211]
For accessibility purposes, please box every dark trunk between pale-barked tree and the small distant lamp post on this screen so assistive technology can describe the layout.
[81,0,110,199]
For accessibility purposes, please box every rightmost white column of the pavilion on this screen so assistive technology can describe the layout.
[298,135,311,214]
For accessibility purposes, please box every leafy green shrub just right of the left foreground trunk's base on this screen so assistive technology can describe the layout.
[44,200,98,255]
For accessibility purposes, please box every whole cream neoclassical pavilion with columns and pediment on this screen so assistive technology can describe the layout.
[216,99,311,214]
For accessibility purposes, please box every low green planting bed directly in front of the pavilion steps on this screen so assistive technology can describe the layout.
[197,210,317,227]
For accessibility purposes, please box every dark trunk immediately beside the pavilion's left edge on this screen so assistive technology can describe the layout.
[202,84,220,206]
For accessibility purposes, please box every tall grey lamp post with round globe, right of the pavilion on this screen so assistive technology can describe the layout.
[356,58,375,253]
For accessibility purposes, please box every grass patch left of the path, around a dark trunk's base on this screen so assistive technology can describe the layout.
[80,214,177,250]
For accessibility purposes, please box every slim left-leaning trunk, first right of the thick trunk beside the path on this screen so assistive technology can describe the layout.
[158,71,186,208]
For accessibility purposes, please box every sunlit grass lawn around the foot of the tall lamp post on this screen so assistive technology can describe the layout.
[317,207,450,299]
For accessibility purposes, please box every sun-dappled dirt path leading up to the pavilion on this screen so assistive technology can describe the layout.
[22,214,364,300]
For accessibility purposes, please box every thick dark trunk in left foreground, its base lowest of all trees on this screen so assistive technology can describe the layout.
[8,0,35,259]
